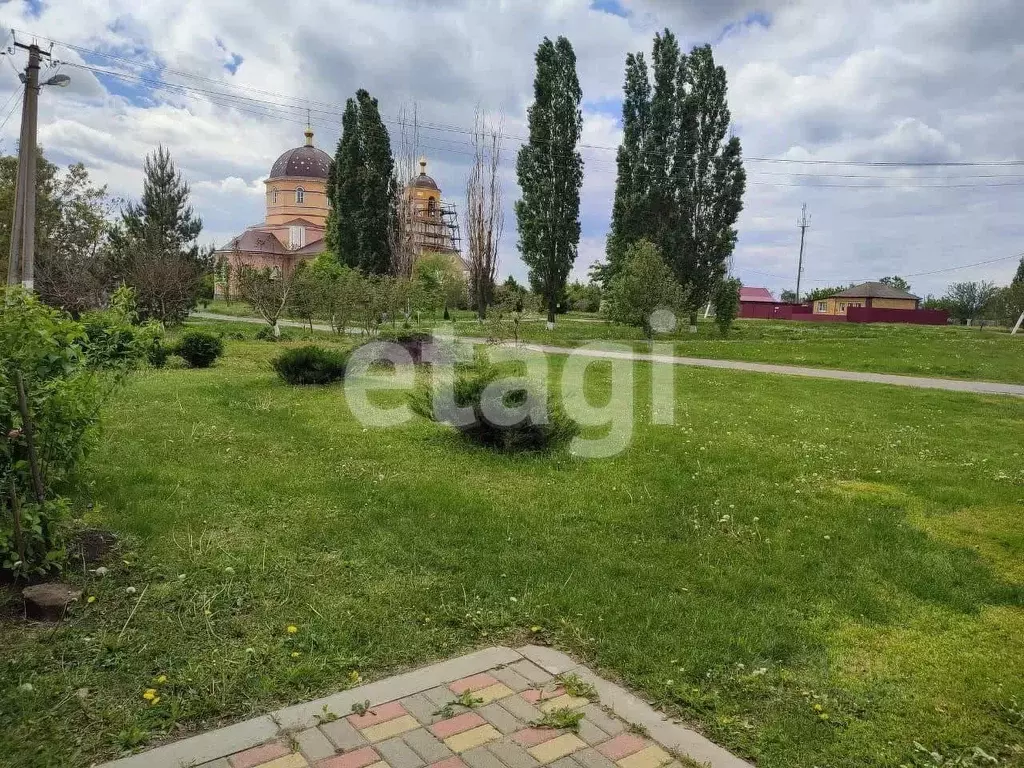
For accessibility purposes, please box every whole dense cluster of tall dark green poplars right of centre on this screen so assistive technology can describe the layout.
[595,30,746,325]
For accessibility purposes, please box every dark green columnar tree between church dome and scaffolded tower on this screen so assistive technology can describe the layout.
[327,88,397,274]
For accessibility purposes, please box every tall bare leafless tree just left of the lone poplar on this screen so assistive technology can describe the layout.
[466,110,505,321]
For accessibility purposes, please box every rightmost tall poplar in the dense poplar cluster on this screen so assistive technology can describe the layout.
[670,45,746,327]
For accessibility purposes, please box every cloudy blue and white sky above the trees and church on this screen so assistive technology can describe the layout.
[0,0,1024,296]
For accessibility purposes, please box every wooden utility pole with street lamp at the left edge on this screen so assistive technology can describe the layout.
[7,41,71,291]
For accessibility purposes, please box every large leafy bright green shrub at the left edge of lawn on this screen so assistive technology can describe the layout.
[0,288,111,575]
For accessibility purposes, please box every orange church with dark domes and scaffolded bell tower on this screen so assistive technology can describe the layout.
[215,128,468,296]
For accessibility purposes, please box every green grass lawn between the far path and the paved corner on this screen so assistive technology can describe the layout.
[0,341,1024,768]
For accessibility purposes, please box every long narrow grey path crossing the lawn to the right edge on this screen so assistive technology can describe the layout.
[193,312,1024,397]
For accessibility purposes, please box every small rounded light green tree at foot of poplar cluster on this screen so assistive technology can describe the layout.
[605,240,686,338]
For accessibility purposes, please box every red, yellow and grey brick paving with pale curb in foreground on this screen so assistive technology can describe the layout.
[100,645,751,768]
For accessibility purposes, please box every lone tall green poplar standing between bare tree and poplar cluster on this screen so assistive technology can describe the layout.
[515,37,583,326]
